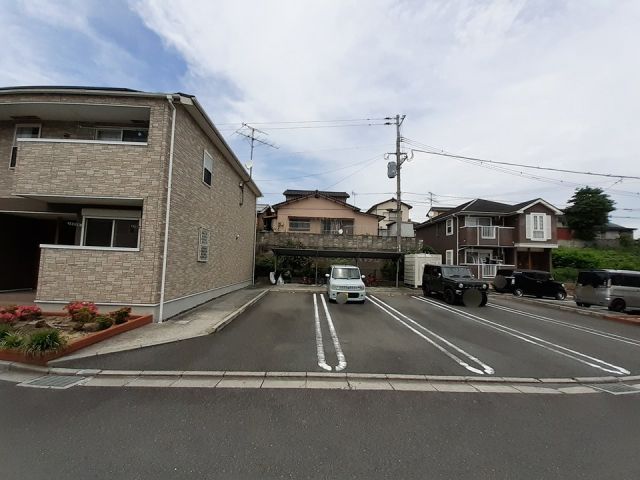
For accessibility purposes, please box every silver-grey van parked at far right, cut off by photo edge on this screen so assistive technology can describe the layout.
[575,270,640,312]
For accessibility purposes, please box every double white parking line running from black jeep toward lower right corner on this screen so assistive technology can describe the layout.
[411,295,630,375]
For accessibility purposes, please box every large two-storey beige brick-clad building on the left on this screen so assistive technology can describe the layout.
[0,87,261,320]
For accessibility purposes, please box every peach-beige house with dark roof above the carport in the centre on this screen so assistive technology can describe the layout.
[271,190,380,235]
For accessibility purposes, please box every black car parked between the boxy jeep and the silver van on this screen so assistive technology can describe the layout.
[493,269,567,300]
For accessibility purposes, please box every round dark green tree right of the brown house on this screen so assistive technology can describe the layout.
[564,187,615,241]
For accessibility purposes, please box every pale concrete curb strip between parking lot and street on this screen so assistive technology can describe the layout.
[0,361,640,385]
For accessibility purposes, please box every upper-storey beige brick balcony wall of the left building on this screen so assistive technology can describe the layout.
[12,138,152,203]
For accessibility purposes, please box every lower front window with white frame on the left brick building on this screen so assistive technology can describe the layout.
[82,209,140,248]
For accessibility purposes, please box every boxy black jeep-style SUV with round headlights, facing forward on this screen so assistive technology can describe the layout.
[422,265,489,307]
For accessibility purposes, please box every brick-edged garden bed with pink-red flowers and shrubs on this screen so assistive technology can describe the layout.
[0,304,152,365]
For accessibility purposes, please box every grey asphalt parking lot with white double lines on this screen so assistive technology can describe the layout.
[56,292,640,378]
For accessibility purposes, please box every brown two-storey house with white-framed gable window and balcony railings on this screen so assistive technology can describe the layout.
[416,198,562,278]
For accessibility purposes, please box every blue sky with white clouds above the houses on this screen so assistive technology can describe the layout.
[0,0,640,237]
